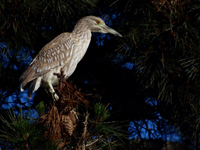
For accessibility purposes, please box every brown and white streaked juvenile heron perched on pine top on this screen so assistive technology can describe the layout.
[20,16,122,100]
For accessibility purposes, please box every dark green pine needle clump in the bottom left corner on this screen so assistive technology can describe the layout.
[0,108,57,150]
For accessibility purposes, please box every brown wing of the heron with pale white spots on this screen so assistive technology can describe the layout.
[20,33,73,90]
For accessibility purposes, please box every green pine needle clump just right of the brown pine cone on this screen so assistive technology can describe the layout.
[89,103,127,149]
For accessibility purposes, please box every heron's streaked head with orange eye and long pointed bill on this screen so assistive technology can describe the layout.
[77,16,122,37]
